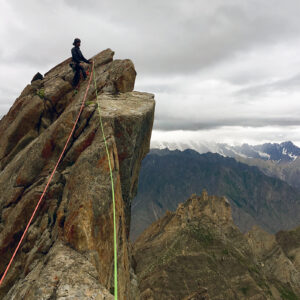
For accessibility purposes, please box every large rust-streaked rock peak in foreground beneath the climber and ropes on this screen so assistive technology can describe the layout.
[0,49,155,300]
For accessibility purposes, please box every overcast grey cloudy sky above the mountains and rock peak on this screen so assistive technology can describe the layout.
[0,0,300,146]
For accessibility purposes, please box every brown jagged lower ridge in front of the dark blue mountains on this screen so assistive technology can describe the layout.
[134,191,300,300]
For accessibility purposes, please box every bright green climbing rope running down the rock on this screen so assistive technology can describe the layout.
[92,61,118,300]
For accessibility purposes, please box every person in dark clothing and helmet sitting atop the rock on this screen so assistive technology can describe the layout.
[70,38,91,87]
